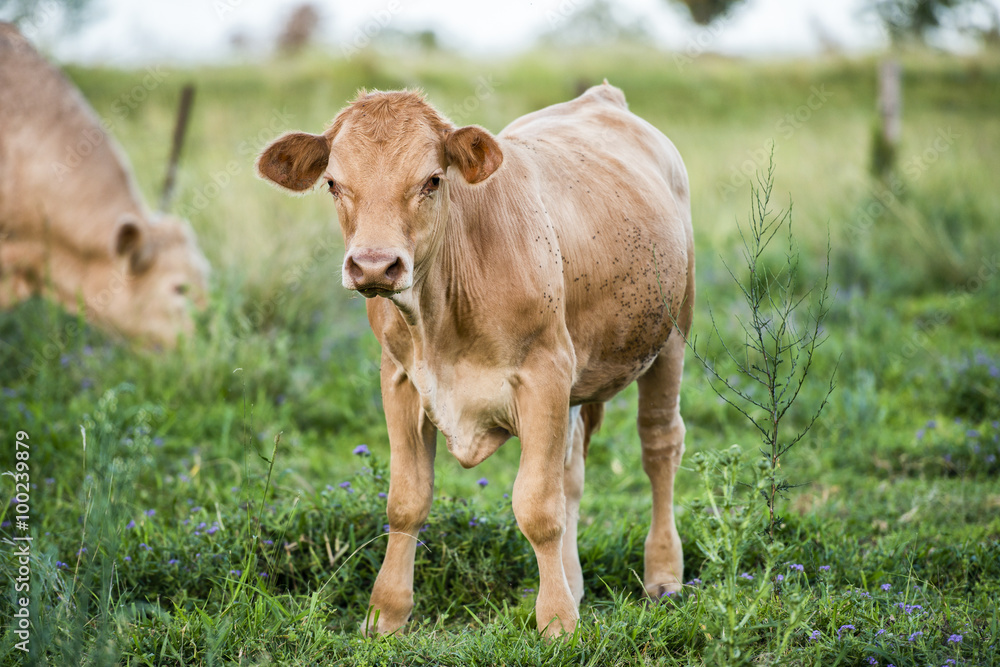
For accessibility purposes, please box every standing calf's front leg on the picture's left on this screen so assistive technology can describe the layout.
[362,355,437,635]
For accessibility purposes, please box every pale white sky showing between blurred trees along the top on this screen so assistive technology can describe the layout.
[9,0,1000,66]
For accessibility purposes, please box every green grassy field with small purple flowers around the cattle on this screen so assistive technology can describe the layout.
[0,44,1000,667]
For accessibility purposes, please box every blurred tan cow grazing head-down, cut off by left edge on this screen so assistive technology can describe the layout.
[0,23,208,346]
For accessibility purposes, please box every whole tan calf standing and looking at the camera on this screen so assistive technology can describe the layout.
[257,82,694,635]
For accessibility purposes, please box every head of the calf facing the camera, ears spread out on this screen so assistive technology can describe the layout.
[257,91,503,298]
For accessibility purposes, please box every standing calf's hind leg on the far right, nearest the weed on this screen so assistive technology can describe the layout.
[638,330,684,598]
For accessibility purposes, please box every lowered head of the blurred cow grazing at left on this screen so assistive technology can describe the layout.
[98,215,209,347]
